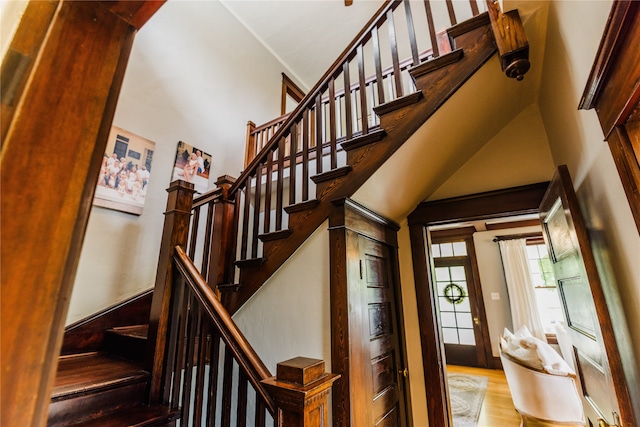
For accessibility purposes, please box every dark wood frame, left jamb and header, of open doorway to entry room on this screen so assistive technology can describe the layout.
[408,182,549,427]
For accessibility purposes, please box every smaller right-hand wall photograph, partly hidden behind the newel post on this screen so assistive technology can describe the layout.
[171,141,211,193]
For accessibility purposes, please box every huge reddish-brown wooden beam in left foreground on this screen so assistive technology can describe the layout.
[0,1,161,426]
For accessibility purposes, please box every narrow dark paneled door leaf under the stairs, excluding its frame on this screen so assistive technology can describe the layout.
[358,236,407,427]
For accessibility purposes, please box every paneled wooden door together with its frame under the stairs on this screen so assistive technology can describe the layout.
[329,199,412,427]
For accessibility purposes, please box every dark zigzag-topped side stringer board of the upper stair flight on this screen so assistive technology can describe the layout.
[222,15,496,314]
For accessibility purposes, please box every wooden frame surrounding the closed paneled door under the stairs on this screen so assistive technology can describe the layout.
[329,198,413,427]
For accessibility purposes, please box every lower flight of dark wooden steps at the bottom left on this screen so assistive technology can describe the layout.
[47,325,179,427]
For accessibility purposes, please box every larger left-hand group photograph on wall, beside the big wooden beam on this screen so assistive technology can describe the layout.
[93,126,156,215]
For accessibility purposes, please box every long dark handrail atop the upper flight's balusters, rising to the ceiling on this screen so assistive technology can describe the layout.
[229,0,402,197]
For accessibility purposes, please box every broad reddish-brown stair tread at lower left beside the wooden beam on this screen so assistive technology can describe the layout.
[51,353,148,400]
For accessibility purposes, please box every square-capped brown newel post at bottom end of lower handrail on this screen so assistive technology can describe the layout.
[262,357,340,427]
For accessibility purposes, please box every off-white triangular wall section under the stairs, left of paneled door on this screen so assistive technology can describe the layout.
[233,221,331,375]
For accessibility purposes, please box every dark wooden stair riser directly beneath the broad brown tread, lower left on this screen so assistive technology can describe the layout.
[47,381,146,427]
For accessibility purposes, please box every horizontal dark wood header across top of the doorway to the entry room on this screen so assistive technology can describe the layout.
[409,182,549,225]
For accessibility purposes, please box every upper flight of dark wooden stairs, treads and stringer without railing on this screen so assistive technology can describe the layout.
[218,13,496,313]
